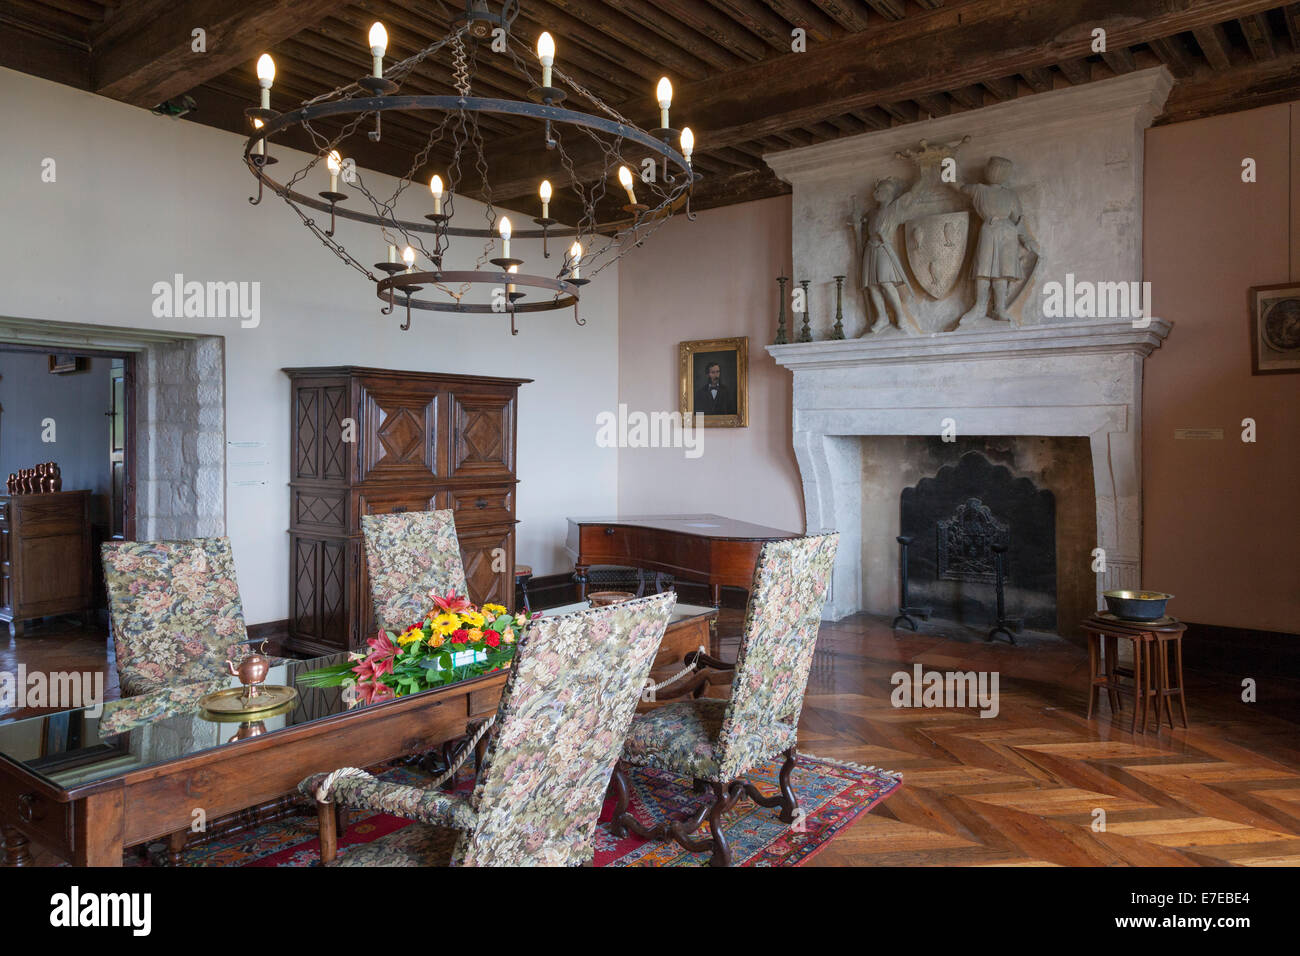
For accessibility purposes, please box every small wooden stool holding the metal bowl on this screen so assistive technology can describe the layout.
[1083,613,1187,734]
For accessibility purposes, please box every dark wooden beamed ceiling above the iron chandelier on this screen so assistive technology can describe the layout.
[0,0,1300,216]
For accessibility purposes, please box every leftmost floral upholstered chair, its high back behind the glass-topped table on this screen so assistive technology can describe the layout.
[100,537,248,696]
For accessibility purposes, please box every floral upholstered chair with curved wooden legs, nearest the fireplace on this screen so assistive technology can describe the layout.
[610,532,840,866]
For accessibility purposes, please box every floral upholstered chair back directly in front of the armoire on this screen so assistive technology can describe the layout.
[361,511,465,631]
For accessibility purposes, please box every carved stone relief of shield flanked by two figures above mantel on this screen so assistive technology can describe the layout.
[852,137,1039,334]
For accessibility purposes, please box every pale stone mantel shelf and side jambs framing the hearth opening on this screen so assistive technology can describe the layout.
[767,317,1170,619]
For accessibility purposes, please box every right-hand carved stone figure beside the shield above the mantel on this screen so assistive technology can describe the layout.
[961,156,1039,324]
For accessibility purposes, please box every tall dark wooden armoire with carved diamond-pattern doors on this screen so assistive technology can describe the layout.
[283,365,532,654]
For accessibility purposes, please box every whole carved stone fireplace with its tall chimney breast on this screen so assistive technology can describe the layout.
[766,69,1171,619]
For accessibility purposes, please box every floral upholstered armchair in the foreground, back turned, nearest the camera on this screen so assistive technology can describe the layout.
[299,592,677,866]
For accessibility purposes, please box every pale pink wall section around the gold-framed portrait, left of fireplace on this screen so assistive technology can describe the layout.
[619,196,803,531]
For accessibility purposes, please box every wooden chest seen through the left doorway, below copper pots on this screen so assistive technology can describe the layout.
[0,492,92,633]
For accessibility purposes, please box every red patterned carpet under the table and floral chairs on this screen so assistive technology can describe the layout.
[129,754,901,866]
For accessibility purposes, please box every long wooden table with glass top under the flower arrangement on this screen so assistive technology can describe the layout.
[0,605,716,866]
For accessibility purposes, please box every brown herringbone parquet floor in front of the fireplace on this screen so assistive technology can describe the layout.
[759,613,1300,866]
